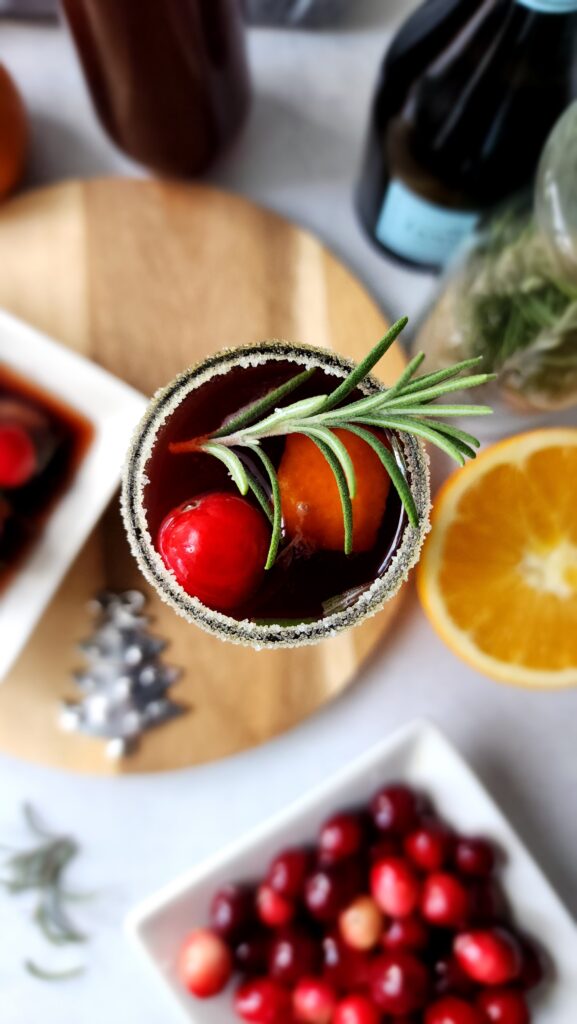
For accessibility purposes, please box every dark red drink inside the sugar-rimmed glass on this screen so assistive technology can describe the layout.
[145,360,405,622]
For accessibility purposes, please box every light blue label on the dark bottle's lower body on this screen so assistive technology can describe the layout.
[375,180,479,266]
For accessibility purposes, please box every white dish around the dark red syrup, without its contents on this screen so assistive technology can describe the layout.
[0,310,147,680]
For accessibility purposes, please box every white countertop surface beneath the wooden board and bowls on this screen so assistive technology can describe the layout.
[0,0,577,1024]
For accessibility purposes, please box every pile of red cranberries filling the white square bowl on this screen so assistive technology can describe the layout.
[179,784,543,1024]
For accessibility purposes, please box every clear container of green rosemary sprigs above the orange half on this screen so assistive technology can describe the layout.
[418,103,577,412]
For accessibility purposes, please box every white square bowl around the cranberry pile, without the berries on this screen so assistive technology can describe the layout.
[127,722,577,1024]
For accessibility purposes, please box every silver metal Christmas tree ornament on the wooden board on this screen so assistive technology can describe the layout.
[59,590,184,759]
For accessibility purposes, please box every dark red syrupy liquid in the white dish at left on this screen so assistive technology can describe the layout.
[0,365,94,588]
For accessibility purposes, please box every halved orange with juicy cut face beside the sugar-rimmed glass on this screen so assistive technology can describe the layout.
[417,428,577,688]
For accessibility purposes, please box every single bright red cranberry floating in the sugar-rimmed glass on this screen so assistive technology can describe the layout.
[157,494,271,611]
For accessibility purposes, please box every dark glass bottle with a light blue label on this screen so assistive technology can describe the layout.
[357,0,577,269]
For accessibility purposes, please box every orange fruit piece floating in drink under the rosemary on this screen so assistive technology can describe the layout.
[278,430,390,552]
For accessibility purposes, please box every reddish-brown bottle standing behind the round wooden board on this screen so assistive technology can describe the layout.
[63,0,250,177]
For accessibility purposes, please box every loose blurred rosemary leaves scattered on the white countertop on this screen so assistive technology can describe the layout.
[0,804,87,980]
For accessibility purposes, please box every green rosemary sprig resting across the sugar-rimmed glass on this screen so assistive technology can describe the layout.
[169,316,494,569]
